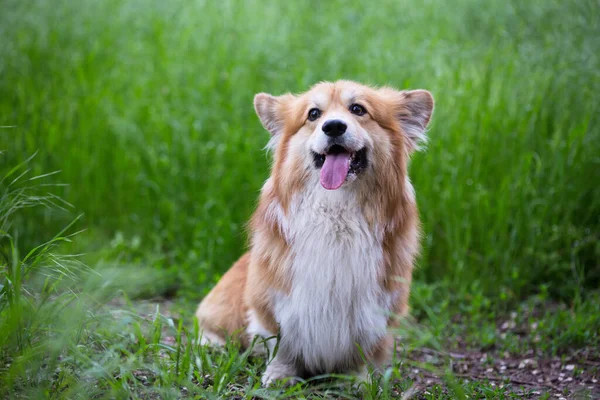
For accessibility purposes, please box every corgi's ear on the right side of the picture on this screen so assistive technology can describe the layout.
[396,89,434,153]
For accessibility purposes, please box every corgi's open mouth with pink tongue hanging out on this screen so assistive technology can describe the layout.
[313,144,368,190]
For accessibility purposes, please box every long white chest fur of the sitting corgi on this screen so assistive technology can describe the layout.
[273,183,393,373]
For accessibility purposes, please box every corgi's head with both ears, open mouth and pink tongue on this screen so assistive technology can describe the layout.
[254,81,433,190]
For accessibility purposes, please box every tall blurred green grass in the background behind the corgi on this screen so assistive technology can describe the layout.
[0,0,600,308]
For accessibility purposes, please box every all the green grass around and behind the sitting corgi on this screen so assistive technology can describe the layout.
[0,0,600,398]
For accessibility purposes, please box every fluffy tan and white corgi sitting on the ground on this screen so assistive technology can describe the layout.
[196,81,433,385]
